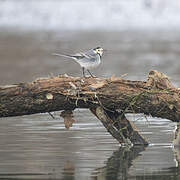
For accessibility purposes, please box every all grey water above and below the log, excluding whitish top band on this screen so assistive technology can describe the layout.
[0,28,180,180]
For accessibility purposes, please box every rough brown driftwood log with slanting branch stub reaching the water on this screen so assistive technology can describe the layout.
[0,71,180,144]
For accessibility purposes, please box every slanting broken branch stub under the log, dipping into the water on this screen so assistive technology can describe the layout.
[90,106,148,147]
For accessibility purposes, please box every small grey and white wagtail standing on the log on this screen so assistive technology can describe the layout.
[52,47,103,77]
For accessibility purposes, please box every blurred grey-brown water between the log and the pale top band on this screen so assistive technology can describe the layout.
[0,28,180,86]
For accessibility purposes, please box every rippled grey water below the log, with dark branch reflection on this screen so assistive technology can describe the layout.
[0,110,179,180]
